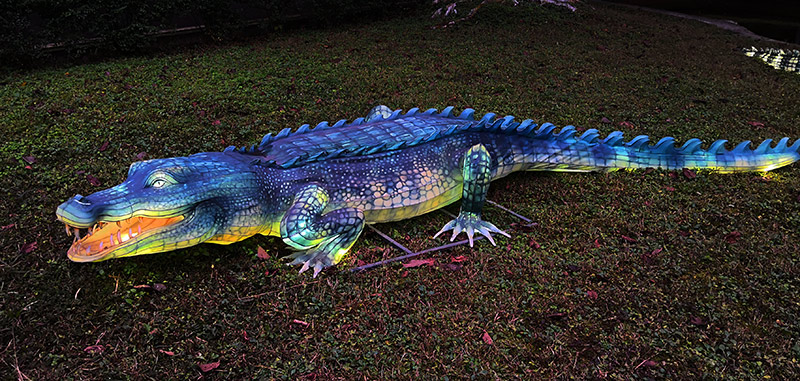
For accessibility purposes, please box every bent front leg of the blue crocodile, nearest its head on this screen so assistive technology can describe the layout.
[281,184,364,277]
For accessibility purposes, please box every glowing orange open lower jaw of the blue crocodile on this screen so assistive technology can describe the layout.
[65,215,184,262]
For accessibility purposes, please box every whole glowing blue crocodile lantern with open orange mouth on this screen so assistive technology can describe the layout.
[56,106,800,276]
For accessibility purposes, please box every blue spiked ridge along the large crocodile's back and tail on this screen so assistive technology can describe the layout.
[242,106,800,168]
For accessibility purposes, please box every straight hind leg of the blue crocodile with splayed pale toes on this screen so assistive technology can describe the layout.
[433,144,509,247]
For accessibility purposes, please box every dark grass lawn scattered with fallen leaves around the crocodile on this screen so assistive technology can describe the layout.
[0,4,800,379]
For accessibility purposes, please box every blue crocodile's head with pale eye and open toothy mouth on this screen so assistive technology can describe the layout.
[56,152,266,262]
